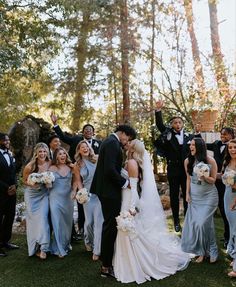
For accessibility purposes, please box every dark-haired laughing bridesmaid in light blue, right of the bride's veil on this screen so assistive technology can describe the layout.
[181,138,218,263]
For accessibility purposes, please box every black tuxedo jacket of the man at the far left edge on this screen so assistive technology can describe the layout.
[0,152,16,197]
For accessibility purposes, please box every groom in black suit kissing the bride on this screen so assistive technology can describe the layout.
[91,125,136,277]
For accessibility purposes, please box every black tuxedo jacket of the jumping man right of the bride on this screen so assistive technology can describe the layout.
[155,111,194,175]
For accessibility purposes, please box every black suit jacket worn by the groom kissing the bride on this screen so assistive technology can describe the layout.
[90,135,126,201]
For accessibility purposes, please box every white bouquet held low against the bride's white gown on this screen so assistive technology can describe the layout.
[116,211,136,234]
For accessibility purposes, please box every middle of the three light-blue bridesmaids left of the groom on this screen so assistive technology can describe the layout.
[49,147,76,258]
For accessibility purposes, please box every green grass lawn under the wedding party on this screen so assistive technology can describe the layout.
[0,217,236,287]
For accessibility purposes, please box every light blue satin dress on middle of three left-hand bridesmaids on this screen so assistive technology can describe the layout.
[49,171,74,256]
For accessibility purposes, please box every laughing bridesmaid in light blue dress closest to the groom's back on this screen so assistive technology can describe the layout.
[75,140,103,261]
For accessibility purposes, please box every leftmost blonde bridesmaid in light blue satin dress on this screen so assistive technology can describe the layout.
[23,143,50,259]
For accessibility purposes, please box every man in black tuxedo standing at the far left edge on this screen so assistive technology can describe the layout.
[0,133,19,257]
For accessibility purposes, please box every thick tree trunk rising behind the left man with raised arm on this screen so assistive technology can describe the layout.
[71,12,90,131]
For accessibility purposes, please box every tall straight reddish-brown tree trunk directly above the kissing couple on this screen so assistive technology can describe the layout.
[120,0,130,124]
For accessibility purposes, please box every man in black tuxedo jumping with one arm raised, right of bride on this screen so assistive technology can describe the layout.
[155,101,200,232]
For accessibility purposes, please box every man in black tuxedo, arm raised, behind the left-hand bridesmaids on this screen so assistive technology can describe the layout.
[51,113,101,241]
